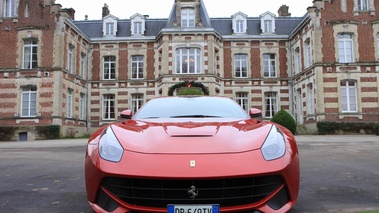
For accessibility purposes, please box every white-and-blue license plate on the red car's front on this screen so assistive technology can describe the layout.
[167,204,220,213]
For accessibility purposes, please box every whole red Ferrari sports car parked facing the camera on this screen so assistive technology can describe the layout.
[85,96,299,213]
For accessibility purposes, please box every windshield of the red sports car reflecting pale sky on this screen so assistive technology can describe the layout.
[134,96,249,119]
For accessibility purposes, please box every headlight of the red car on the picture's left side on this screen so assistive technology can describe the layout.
[99,127,124,162]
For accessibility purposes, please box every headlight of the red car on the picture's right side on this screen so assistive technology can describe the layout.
[261,126,286,160]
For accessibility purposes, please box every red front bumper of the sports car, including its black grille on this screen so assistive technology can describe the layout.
[85,141,299,213]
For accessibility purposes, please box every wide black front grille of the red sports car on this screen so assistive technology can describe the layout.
[102,176,283,208]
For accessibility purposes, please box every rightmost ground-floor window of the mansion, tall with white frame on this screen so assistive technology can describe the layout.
[341,80,358,112]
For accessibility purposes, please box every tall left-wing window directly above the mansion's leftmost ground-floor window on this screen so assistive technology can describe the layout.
[22,38,38,69]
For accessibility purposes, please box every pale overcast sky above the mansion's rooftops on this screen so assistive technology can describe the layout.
[55,0,313,20]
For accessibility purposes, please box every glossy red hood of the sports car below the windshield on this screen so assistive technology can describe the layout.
[111,118,272,154]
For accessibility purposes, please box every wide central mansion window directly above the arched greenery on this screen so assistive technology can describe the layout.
[176,48,201,74]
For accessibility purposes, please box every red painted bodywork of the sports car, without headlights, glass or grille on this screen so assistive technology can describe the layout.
[85,97,300,212]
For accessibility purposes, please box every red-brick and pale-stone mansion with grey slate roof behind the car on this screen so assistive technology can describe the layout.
[0,0,379,140]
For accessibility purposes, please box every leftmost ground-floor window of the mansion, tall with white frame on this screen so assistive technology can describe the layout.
[21,85,37,117]
